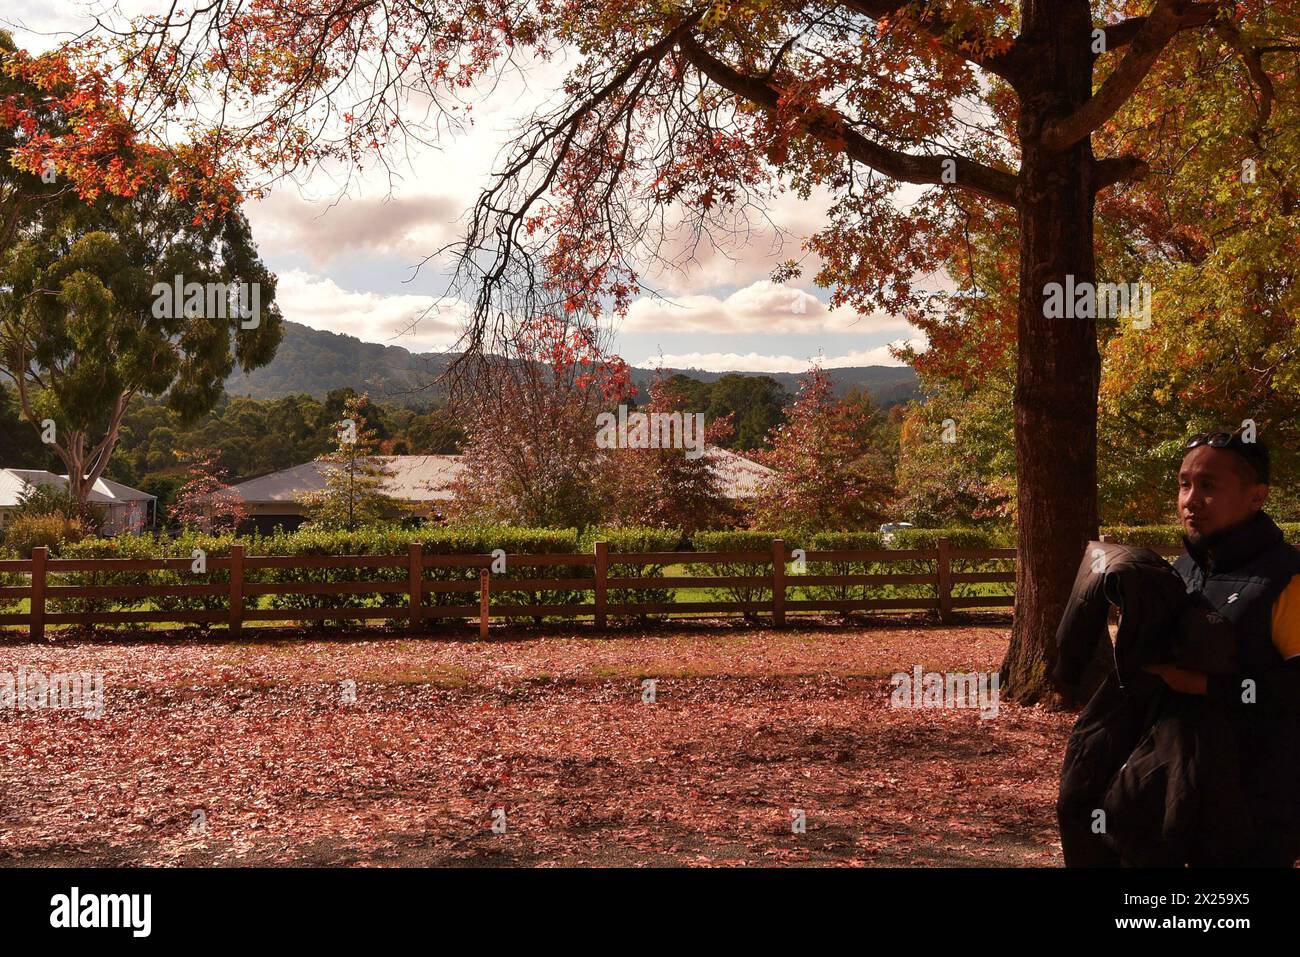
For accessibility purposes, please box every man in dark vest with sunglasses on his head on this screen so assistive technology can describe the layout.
[1147,430,1300,867]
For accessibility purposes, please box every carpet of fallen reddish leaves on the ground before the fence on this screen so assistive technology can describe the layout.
[0,627,1070,866]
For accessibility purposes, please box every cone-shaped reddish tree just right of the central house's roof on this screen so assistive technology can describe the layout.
[753,367,893,532]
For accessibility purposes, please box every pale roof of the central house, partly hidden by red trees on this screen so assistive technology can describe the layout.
[231,446,772,506]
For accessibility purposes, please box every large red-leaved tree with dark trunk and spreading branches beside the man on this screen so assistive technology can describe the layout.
[106,0,1300,702]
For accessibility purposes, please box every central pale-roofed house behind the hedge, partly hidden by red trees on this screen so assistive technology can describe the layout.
[223,446,772,532]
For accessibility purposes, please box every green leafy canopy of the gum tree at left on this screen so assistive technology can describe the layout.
[0,153,281,498]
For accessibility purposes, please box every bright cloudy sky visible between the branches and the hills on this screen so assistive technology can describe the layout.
[0,0,920,372]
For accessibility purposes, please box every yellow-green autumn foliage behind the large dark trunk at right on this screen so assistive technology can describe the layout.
[904,3,1300,535]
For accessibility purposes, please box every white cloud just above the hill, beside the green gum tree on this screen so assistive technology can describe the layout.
[276,269,468,352]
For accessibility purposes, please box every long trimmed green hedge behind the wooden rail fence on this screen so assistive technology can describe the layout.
[0,523,1300,629]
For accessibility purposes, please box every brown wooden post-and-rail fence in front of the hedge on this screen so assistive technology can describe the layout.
[0,538,1177,640]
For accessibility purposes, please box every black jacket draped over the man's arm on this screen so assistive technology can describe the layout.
[1054,542,1251,866]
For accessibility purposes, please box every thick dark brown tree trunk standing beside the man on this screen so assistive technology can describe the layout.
[1001,0,1101,702]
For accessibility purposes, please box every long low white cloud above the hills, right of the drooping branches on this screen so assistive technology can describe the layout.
[619,280,911,335]
